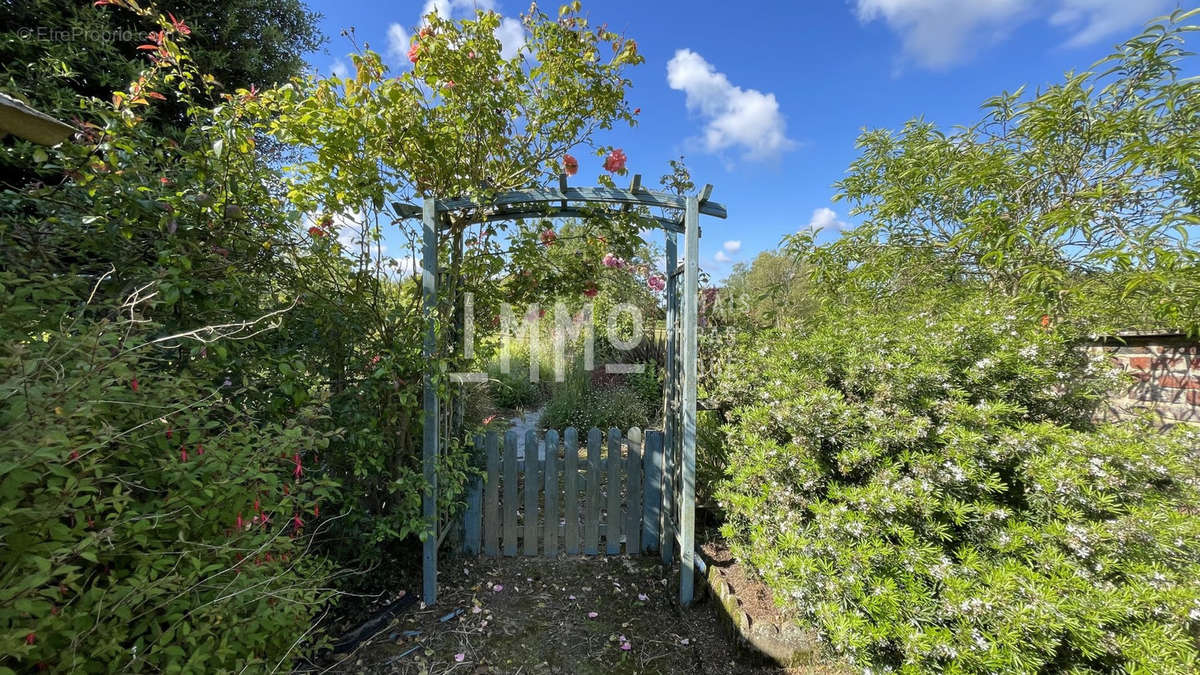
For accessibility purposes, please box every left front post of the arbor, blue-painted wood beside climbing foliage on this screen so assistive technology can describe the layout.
[421,197,439,605]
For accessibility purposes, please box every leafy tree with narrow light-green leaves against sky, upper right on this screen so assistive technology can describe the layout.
[791,10,1200,333]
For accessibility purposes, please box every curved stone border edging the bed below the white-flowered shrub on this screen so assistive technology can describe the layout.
[697,551,821,668]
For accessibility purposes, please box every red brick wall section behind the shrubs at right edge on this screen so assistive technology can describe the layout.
[1087,333,1200,425]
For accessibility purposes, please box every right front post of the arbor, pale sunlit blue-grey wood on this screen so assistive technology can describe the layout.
[679,196,700,607]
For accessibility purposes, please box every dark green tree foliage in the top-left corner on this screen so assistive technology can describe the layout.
[0,0,324,123]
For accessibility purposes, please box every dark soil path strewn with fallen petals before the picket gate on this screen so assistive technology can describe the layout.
[318,557,841,675]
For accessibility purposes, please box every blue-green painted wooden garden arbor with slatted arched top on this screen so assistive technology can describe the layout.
[412,175,726,605]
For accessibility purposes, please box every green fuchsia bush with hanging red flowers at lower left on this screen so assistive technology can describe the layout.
[0,273,334,673]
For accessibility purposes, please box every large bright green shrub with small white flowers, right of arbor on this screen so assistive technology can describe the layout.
[714,298,1200,673]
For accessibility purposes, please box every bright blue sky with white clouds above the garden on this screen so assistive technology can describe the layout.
[308,0,1194,279]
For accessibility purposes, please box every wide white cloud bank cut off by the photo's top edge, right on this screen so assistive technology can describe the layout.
[854,0,1172,70]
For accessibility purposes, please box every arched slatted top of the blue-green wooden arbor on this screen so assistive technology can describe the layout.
[395,174,727,233]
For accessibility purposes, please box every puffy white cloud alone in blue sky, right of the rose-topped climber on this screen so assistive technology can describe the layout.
[667,49,796,160]
